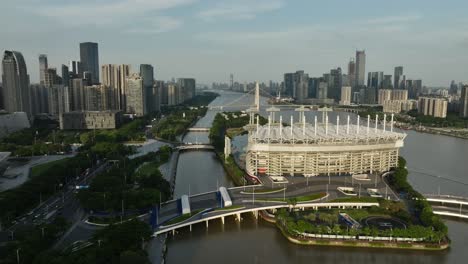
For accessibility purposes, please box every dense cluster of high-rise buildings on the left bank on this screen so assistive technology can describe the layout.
[0,42,196,129]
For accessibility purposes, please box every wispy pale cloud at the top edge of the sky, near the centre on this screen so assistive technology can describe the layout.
[197,0,285,22]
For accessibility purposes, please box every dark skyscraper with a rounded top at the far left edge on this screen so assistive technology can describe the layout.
[2,50,32,117]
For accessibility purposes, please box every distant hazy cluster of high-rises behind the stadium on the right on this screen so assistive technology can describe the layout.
[281,50,423,105]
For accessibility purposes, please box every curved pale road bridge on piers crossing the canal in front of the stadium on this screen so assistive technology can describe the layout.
[152,185,379,236]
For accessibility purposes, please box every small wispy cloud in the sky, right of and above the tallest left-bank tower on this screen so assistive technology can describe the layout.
[125,16,183,34]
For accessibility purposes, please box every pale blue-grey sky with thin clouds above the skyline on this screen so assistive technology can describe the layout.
[0,0,468,86]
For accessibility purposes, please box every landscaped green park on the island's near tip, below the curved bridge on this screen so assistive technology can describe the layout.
[275,196,444,243]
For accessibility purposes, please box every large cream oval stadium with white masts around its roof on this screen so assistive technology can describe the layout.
[245,109,406,177]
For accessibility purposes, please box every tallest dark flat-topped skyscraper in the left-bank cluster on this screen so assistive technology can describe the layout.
[80,42,99,84]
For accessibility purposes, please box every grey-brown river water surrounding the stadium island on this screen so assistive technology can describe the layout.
[158,92,468,264]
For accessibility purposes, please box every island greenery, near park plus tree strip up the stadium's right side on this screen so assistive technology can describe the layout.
[275,158,450,250]
